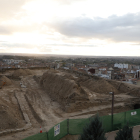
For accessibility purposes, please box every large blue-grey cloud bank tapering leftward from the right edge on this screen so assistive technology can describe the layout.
[47,13,140,42]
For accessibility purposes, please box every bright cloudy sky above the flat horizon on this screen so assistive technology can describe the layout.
[0,0,140,56]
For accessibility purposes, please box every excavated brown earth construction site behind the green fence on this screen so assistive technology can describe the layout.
[0,68,140,140]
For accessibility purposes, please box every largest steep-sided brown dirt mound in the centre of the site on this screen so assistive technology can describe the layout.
[40,72,88,107]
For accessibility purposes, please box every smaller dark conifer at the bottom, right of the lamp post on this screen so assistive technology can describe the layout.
[115,124,134,140]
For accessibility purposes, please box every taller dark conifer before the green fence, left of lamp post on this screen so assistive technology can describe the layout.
[79,116,107,140]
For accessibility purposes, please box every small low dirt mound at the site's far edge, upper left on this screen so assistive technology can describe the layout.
[12,69,32,77]
